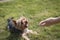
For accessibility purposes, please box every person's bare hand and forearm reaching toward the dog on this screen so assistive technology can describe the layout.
[39,17,60,26]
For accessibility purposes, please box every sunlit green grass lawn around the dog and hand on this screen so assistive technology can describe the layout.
[0,0,60,40]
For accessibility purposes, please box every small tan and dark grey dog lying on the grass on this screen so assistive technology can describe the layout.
[8,17,37,40]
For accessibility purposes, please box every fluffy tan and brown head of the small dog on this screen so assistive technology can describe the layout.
[17,17,28,30]
